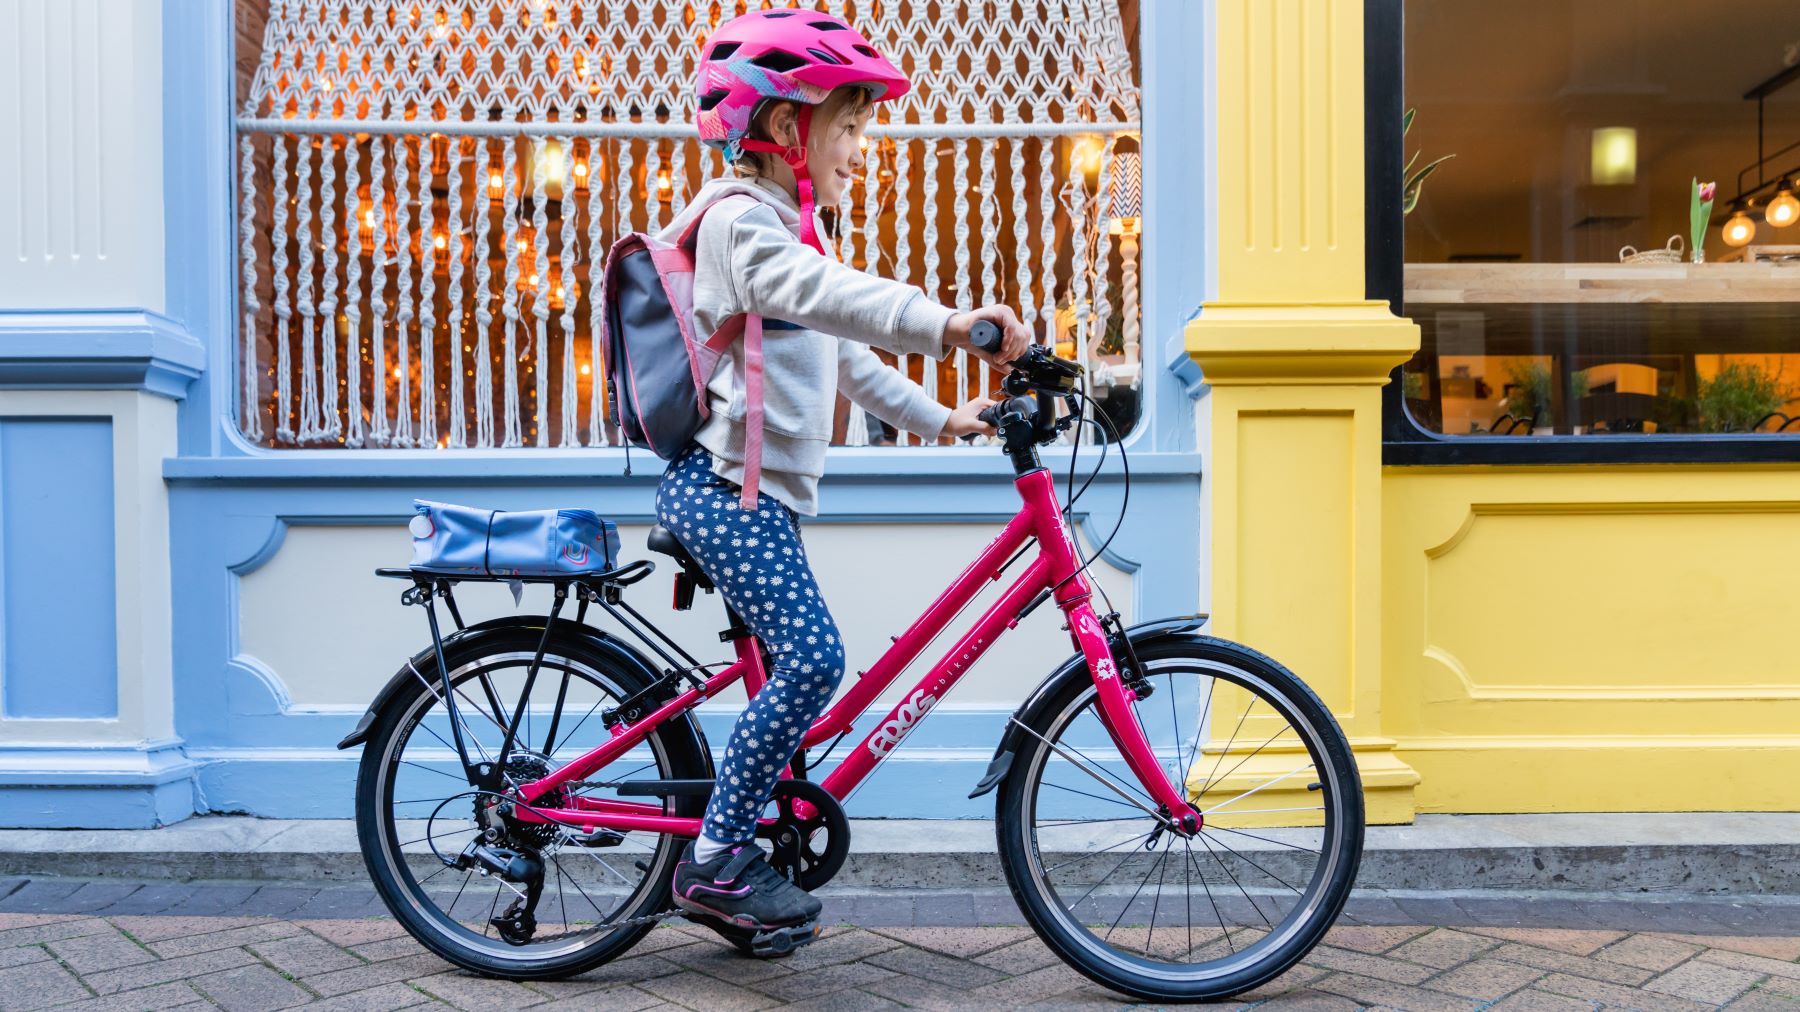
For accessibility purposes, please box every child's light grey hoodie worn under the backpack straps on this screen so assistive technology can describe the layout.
[659,178,956,515]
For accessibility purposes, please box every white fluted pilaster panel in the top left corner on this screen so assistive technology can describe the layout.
[0,0,166,312]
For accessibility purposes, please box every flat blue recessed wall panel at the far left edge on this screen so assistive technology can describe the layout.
[0,416,119,717]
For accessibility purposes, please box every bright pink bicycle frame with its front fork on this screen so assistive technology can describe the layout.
[517,468,1199,837]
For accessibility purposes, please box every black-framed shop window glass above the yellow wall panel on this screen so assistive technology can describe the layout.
[1399,0,1800,441]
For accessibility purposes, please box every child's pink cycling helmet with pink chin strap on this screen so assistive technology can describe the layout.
[695,9,911,248]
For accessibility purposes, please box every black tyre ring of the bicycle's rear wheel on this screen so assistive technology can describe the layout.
[356,625,713,981]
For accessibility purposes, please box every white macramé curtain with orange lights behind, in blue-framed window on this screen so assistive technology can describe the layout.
[236,0,1139,448]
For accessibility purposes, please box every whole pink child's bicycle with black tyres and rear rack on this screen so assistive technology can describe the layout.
[340,333,1363,1001]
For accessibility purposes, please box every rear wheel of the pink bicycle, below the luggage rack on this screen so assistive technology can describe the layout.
[356,625,711,980]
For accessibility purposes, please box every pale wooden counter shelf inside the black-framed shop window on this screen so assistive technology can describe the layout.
[1406,263,1800,308]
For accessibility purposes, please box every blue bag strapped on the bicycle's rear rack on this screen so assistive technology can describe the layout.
[409,499,619,578]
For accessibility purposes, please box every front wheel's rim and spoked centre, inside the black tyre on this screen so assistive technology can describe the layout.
[1019,657,1348,983]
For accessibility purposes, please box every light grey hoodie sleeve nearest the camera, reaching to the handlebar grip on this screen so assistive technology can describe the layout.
[709,205,956,358]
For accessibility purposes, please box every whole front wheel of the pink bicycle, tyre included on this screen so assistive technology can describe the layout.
[995,637,1363,1001]
